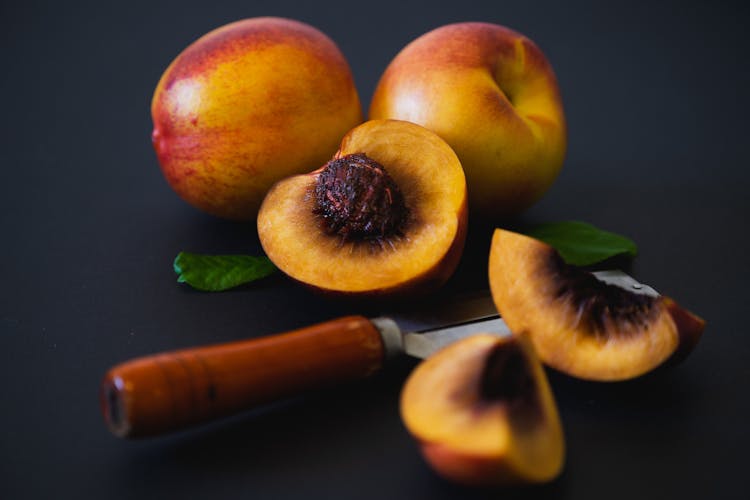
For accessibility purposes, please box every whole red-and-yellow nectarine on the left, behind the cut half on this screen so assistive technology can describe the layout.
[151,17,362,220]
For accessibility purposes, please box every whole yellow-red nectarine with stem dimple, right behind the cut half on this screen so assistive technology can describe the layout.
[369,23,567,217]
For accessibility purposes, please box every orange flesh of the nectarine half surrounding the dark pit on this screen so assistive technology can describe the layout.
[258,120,467,294]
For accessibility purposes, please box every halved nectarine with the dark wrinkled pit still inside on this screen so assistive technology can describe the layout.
[258,120,467,296]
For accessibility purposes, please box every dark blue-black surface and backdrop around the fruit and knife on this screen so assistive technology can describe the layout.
[0,0,750,499]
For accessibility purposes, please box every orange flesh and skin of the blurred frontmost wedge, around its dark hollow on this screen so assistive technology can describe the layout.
[401,334,565,484]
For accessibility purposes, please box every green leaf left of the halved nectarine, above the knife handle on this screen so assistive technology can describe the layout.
[174,252,276,292]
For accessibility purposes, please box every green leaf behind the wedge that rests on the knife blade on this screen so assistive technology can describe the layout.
[526,221,638,266]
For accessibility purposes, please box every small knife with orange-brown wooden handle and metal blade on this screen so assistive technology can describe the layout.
[100,271,658,438]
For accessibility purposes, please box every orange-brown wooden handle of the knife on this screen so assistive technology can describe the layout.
[100,316,385,437]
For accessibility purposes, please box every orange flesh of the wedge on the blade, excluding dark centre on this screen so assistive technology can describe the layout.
[489,229,703,381]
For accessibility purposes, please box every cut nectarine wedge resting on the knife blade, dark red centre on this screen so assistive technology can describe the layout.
[489,229,704,381]
